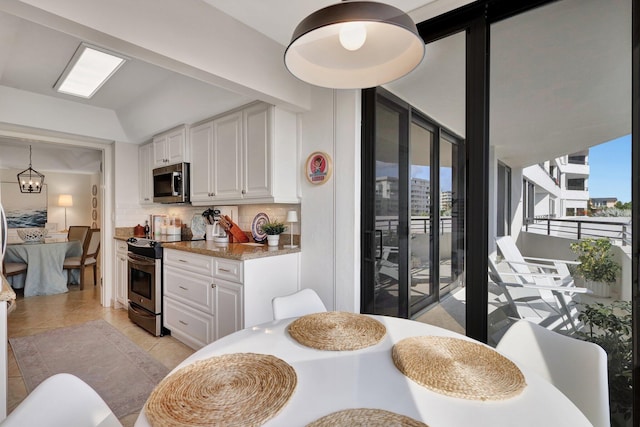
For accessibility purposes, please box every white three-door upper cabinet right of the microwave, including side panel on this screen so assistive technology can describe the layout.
[189,103,300,205]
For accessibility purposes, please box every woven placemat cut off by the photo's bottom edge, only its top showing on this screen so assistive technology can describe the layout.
[307,408,428,427]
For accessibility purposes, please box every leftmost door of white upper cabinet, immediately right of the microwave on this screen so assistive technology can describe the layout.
[189,122,213,202]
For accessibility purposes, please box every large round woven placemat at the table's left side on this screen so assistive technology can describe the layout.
[144,353,297,427]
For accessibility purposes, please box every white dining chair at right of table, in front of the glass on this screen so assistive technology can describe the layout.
[496,320,611,427]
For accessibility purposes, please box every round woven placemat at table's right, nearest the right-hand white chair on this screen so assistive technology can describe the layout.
[392,336,527,400]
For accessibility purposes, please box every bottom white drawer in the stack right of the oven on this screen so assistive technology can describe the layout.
[164,297,215,348]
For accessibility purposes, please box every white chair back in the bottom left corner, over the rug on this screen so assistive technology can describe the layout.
[0,374,122,427]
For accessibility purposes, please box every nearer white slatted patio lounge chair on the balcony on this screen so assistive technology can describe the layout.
[489,257,591,333]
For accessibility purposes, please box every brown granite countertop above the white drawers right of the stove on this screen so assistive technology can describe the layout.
[162,240,300,261]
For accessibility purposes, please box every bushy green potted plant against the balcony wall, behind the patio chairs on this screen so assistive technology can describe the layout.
[571,238,620,297]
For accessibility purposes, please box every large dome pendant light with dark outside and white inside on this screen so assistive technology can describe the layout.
[284,1,424,89]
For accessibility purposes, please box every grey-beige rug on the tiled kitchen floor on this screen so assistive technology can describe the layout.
[9,320,169,418]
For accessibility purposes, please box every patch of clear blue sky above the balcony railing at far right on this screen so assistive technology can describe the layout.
[588,135,631,203]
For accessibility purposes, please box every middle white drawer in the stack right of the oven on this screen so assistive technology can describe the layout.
[164,265,215,314]
